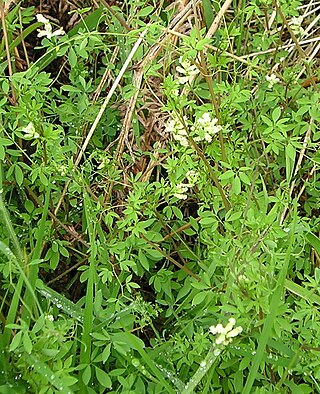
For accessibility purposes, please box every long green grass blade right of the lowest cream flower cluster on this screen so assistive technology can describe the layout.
[243,201,298,394]
